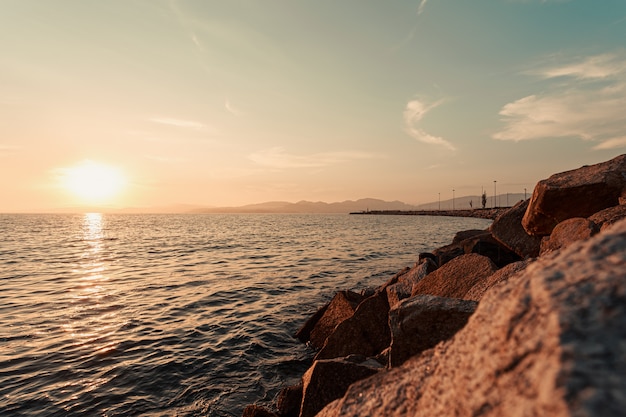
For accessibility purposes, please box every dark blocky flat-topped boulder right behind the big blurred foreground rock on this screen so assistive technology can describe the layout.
[389,295,478,367]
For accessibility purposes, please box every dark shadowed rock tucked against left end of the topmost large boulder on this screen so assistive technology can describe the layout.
[489,200,541,259]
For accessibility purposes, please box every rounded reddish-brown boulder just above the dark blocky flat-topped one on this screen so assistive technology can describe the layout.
[411,253,498,298]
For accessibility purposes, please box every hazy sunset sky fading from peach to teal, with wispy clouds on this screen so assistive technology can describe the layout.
[0,0,626,212]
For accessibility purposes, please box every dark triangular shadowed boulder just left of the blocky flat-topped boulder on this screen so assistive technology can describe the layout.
[315,291,391,360]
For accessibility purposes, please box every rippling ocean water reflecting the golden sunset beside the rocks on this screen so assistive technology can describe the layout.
[0,213,490,416]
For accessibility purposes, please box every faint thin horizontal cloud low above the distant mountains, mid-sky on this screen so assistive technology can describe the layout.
[248,147,380,169]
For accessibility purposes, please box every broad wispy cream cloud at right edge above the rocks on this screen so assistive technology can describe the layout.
[493,54,626,149]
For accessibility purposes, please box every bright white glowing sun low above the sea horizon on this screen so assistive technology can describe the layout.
[61,160,127,204]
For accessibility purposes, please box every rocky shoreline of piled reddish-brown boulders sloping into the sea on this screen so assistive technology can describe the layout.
[243,155,626,417]
